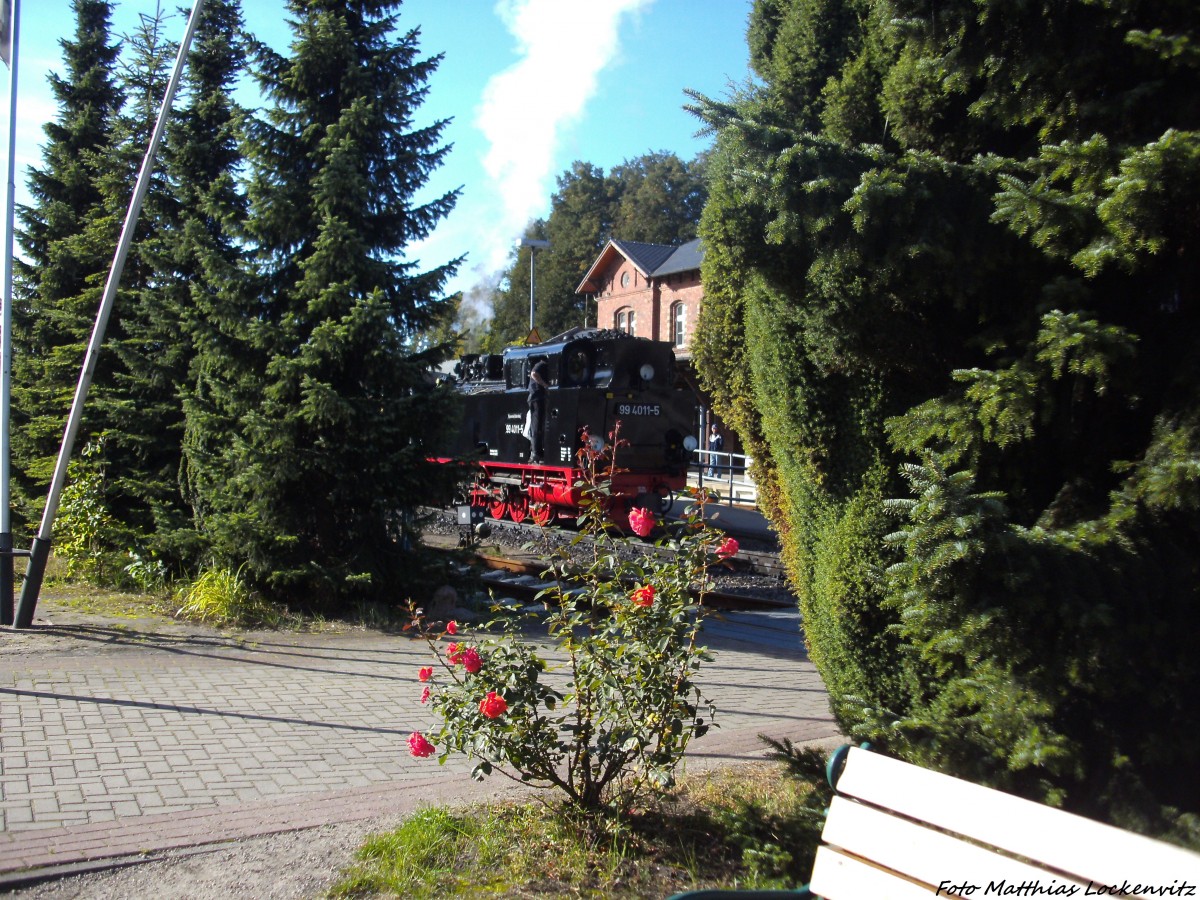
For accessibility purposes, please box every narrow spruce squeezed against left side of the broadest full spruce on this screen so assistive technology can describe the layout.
[174,0,253,562]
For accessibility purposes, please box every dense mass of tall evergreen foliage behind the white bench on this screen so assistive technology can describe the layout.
[696,0,1200,841]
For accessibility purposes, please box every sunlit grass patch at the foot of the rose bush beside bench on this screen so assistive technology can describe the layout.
[330,763,822,900]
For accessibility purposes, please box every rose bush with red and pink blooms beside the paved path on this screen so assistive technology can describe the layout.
[409,422,737,814]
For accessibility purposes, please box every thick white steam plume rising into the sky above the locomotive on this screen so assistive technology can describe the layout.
[475,0,653,277]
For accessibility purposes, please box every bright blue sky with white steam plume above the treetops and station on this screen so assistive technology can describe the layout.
[0,0,751,303]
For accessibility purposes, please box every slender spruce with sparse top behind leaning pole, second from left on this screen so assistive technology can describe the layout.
[80,6,188,562]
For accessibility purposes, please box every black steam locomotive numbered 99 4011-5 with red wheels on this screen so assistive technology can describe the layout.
[452,330,696,522]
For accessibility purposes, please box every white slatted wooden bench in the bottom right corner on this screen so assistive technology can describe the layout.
[672,746,1200,900]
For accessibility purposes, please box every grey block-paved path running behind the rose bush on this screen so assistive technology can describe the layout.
[0,600,838,880]
